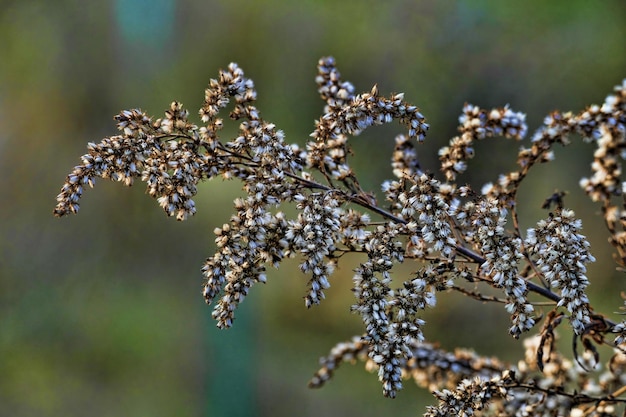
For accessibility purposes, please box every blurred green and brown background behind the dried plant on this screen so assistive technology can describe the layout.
[0,0,626,417]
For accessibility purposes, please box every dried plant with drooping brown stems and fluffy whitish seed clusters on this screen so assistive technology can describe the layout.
[54,58,626,416]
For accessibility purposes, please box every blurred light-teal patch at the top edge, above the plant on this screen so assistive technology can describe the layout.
[114,0,175,47]
